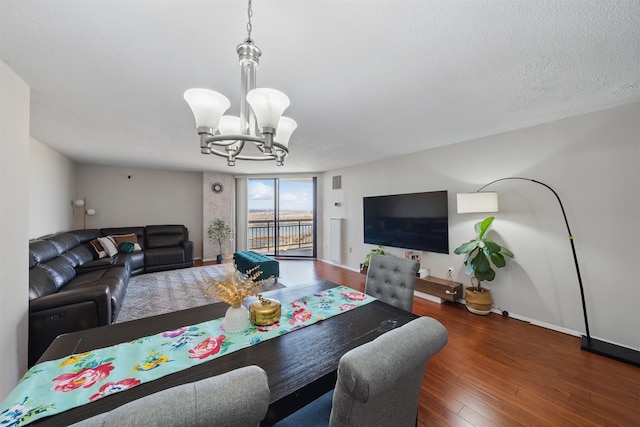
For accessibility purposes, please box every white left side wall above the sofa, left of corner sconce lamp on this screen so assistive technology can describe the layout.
[29,138,75,239]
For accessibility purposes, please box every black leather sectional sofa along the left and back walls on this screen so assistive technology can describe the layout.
[29,225,194,366]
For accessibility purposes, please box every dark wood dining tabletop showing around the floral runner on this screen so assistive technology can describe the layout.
[34,280,417,425]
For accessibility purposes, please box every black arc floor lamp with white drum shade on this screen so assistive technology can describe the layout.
[457,176,640,367]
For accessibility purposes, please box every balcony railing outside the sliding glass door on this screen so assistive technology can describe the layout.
[248,219,313,252]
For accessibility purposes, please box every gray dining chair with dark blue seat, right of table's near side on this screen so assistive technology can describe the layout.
[275,317,448,427]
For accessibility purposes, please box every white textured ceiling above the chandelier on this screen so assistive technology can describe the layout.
[0,0,640,174]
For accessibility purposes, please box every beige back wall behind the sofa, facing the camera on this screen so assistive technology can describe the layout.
[74,164,202,258]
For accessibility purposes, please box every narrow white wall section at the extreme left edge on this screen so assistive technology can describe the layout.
[0,62,29,401]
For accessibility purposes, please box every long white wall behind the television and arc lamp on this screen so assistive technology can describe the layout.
[320,104,640,349]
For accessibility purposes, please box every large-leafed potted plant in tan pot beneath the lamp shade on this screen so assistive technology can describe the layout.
[453,216,513,315]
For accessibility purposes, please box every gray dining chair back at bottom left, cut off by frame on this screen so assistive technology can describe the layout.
[73,365,271,427]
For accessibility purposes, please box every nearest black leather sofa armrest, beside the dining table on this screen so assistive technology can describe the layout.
[29,286,111,326]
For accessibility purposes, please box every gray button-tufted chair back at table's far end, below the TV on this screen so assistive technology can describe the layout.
[365,254,419,311]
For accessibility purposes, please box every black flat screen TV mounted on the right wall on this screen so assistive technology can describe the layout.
[363,191,449,254]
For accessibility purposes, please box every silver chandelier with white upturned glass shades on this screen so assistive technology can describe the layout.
[184,0,297,166]
